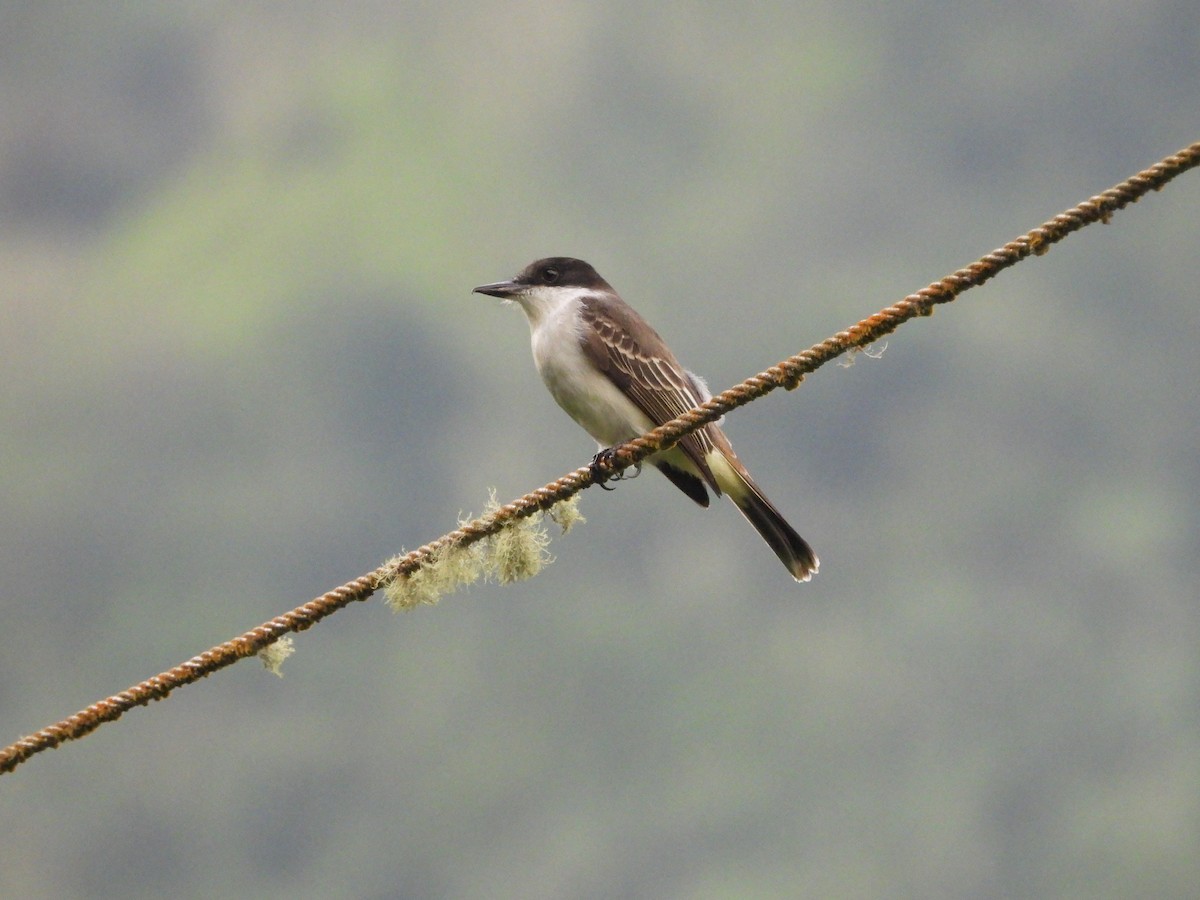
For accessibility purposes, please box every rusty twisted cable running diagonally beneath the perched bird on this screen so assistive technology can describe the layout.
[0,142,1200,774]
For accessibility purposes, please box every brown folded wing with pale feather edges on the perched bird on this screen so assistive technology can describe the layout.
[580,295,720,494]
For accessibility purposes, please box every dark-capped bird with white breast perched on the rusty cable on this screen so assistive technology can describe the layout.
[472,257,821,582]
